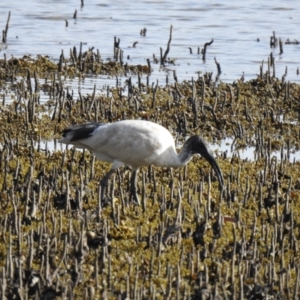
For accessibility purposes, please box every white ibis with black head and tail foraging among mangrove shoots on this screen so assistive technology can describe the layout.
[59,120,224,203]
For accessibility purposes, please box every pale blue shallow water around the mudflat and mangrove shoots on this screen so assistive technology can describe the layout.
[0,0,300,157]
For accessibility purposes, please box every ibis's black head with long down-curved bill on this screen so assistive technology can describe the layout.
[185,135,224,190]
